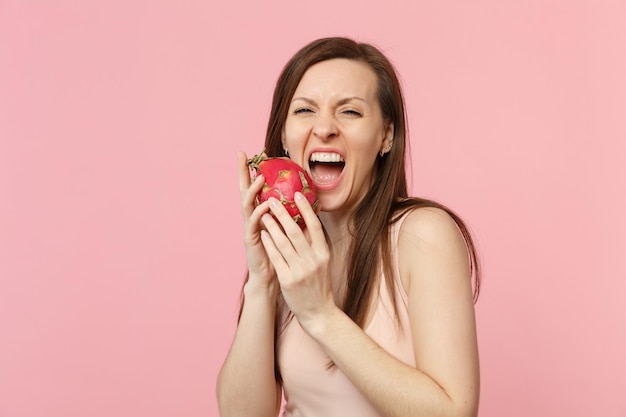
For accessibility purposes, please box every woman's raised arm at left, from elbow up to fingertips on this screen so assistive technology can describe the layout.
[217,152,281,417]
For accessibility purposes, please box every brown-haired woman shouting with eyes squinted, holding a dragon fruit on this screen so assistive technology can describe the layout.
[217,38,479,417]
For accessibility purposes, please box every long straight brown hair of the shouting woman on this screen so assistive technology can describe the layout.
[265,37,480,327]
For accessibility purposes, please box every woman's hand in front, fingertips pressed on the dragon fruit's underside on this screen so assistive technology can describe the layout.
[261,193,336,331]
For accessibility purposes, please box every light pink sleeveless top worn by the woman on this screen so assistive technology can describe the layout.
[277,216,415,417]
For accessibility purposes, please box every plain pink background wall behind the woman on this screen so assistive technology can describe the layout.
[0,0,626,417]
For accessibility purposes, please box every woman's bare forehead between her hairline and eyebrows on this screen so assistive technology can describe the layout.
[295,58,378,100]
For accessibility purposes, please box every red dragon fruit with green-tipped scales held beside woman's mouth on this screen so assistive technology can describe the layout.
[248,152,319,229]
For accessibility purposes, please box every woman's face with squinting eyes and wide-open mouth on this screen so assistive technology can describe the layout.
[282,59,393,212]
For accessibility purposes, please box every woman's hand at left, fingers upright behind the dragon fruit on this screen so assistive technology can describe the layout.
[239,151,276,285]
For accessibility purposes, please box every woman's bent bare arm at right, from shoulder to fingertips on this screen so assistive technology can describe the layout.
[263,198,479,417]
